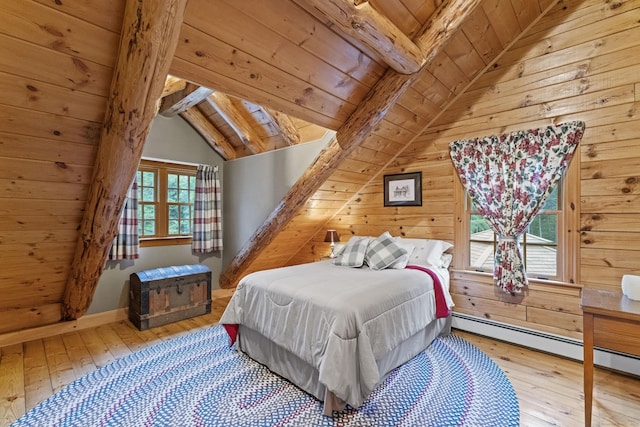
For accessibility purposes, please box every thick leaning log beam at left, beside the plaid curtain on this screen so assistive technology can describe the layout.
[62,0,187,320]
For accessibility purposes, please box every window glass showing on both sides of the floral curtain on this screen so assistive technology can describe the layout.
[466,184,562,279]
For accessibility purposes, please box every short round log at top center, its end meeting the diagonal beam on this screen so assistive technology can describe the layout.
[306,0,425,74]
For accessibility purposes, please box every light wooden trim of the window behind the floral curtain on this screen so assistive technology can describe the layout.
[453,153,580,284]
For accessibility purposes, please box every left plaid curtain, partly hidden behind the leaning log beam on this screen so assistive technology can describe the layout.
[109,176,140,260]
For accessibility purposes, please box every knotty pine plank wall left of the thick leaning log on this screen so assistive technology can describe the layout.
[0,0,124,333]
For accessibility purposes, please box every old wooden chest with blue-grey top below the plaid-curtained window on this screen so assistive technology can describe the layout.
[129,264,211,331]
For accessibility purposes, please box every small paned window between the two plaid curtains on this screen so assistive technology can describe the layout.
[137,160,196,244]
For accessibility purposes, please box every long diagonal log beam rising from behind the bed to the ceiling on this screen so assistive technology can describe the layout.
[220,0,482,288]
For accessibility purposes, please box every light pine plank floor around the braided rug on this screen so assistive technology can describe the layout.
[0,299,640,427]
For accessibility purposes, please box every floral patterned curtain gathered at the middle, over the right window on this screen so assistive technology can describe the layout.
[449,121,585,294]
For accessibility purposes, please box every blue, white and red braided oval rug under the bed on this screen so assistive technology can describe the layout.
[13,326,520,427]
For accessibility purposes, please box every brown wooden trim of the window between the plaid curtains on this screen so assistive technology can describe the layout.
[137,158,198,247]
